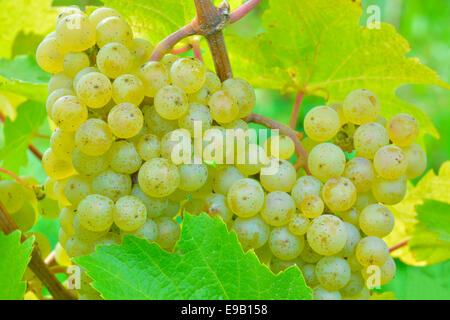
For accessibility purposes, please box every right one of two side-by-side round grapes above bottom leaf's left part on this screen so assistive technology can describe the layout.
[114,196,147,231]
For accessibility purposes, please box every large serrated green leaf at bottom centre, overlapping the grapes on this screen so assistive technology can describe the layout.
[75,214,311,300]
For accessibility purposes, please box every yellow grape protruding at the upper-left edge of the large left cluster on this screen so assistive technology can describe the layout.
[36,38,64,73]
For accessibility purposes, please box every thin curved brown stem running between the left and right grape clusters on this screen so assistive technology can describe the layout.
[244,113,311,175]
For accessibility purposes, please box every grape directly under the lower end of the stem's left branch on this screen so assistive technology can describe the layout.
[137,61,169,97]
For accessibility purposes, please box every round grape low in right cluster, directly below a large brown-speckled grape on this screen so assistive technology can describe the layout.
[316,257,351,291]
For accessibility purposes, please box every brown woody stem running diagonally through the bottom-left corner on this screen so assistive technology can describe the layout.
[0,202,76,300]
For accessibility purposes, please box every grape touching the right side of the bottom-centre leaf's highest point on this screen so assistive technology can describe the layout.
[232,216,270,251]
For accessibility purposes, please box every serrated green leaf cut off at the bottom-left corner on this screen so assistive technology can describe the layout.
[0,231,34,300]
